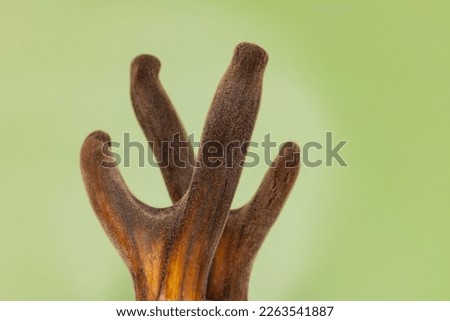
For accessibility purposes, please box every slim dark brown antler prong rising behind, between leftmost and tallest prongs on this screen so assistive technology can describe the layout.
[130,55,194,203]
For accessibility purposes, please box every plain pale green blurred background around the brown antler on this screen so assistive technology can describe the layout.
[0,0,450,300]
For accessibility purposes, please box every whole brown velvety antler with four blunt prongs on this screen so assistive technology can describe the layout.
[81,43,299,300]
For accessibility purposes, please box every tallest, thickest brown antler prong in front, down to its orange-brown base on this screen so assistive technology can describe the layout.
[160,43,267,299]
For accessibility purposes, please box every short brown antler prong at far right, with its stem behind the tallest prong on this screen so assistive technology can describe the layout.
[207,143,300,300]
